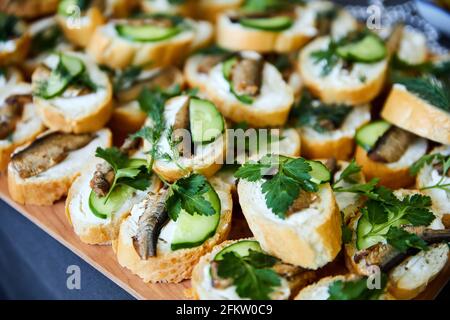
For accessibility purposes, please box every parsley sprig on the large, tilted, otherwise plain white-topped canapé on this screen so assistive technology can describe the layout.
[235,155,318,219]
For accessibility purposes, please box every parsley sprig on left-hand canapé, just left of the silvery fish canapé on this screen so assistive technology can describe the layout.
[95,147,150,204]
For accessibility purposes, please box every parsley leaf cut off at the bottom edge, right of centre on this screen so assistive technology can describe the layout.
[328,274,387,300]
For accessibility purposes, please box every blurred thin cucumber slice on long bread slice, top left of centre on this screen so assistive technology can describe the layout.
[116,25,181,42]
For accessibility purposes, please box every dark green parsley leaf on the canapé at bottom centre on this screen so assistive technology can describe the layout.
[217,250,281,300]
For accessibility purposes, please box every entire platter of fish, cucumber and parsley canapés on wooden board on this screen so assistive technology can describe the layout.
[0,0,450,300]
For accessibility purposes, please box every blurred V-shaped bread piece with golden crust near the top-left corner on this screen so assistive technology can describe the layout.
[56,6,106,48]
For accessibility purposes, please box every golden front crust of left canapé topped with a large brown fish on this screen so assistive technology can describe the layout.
[8,130,112,206]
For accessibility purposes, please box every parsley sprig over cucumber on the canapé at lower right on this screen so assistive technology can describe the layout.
[357,187,435,252]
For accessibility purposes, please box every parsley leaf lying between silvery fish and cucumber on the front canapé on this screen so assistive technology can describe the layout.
[166,174,215,221]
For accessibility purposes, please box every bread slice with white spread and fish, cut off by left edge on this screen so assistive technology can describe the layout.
[0,83,45,171]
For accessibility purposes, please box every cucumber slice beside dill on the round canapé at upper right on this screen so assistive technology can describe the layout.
[337,35,387,63]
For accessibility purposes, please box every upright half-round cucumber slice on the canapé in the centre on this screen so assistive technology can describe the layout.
[189,98,224,144]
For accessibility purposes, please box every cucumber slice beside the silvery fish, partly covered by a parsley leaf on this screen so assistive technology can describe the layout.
[170,186,221,251]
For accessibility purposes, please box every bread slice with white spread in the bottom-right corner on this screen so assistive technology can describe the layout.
[388,243,449,300]
